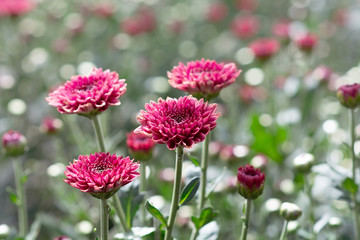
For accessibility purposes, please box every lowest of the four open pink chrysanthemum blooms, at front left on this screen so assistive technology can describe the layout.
[64,152,140,199]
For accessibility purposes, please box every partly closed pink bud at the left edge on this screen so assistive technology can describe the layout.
[2,130,28,157]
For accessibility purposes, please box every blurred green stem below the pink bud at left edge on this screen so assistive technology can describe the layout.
[12,159,28,238]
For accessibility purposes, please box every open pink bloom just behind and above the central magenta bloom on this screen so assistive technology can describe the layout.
[167,59,241,100]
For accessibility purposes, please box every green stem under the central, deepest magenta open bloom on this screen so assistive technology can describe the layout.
[165,146,184,240]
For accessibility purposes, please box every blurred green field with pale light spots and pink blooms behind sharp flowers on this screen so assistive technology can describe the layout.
[0,0,360,240]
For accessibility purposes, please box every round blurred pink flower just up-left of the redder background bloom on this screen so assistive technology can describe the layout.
[231,15,259,39]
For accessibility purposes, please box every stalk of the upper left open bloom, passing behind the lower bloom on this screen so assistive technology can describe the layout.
[91,115,131,232]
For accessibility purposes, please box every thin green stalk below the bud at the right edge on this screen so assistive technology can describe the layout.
[350,108,360,239]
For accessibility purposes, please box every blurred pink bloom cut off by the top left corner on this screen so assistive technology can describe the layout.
[0,0,35,17]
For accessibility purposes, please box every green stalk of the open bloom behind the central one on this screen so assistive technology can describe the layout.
[197,134,210,212]
